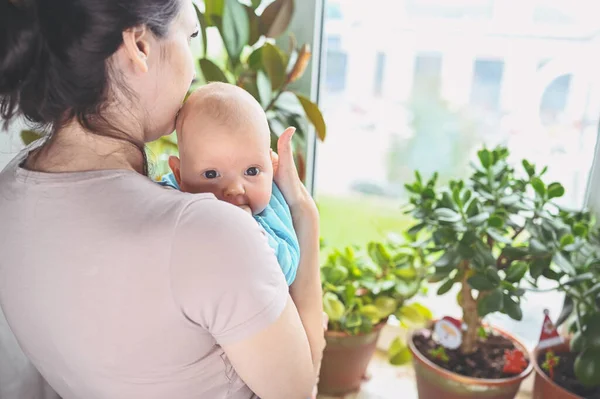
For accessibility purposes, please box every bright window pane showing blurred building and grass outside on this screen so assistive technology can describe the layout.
[315,0,600,344]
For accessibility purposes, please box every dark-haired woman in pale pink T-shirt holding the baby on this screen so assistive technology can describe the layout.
[0,0,324,399]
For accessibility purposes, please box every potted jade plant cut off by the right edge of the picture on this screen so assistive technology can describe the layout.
[533,211,600,399]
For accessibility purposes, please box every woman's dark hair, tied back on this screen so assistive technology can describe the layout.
[0,0,181,173]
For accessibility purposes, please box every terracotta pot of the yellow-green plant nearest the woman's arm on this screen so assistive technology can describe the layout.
[319,322,386,396]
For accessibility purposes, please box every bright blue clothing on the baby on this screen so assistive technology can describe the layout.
[158,173,300,285]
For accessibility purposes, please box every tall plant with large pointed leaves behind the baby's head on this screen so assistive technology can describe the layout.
[21,0,326,184]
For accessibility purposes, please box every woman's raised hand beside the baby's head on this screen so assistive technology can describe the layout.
[271,127,317,214]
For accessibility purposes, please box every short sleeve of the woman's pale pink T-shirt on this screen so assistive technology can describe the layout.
[170,199,288,344]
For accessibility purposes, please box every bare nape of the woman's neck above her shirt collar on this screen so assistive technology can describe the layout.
[25,123,145,173]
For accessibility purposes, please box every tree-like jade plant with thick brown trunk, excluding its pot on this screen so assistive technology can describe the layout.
[406,147,564,354]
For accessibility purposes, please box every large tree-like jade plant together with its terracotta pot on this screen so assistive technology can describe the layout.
[406,147,564,399]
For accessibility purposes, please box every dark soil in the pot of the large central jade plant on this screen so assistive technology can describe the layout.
[413,333,528,379]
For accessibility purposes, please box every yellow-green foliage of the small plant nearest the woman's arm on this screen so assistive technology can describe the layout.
[321,236,431,342]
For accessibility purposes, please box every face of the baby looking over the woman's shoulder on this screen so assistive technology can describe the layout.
[180,114,273,215]
